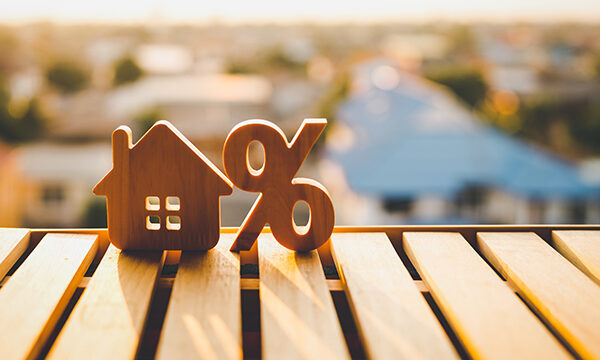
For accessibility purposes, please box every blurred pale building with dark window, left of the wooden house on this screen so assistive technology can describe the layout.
[12,143,112,227]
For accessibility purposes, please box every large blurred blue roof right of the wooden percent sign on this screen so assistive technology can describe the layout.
[327,64,598,198]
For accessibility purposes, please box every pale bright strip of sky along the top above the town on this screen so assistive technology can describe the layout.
[0,0,600,24]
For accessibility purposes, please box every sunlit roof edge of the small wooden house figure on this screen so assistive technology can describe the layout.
[94,120,233,194]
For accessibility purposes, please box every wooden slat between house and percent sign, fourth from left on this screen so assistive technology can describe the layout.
[157,234,242,359]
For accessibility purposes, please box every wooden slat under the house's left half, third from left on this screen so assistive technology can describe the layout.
[49,245,164,359]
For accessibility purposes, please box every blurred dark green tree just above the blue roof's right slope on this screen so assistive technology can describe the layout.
[424,65,488,108]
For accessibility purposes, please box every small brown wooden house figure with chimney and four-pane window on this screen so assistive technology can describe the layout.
[93,120,233,250]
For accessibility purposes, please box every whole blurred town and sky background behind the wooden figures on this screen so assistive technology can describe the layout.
[0,0,600,227]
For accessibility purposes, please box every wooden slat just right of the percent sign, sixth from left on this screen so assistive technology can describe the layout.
[331,233,458,359]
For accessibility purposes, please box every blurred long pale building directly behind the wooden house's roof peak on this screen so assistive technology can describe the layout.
[106,74,272,142]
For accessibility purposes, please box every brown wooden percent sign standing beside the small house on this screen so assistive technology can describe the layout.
[223,119,334,251]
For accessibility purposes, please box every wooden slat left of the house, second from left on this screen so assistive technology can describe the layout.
[0,234,98,359]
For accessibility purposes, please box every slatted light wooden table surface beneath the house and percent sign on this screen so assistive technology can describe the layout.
[0,225,600,359]
